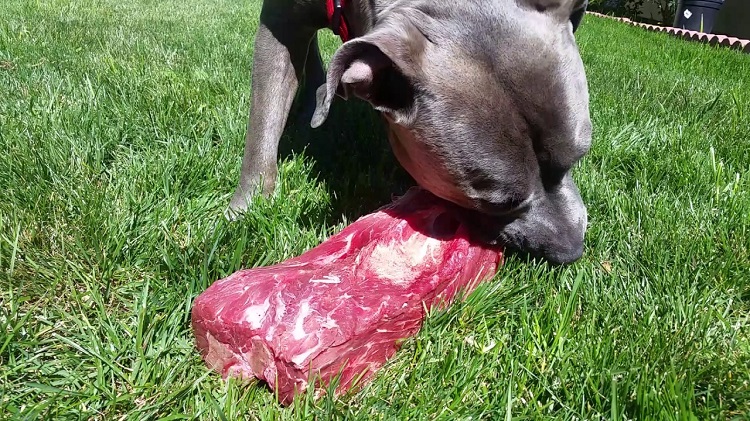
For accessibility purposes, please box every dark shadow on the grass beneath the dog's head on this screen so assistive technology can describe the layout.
[279,92,416,223]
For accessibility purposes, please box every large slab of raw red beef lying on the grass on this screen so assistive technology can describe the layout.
[192,187,502,403]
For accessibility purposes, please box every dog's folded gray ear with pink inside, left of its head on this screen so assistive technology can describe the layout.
[311,21,425,128]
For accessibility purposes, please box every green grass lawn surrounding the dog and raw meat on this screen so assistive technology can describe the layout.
[0,0,750,420]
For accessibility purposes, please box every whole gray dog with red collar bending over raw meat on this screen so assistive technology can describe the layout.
[229,0,591,263]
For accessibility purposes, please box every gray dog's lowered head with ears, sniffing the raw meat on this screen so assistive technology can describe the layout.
[312,0,591,263]
